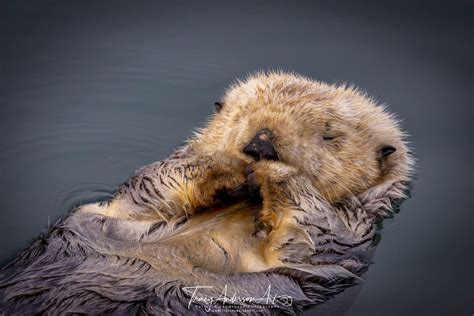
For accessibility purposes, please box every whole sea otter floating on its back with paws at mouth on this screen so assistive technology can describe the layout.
[0,72,413,314]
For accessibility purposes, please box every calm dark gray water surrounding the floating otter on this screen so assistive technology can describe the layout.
[0,0,474,315]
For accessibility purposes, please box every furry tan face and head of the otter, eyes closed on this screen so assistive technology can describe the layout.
[195,73,410,202]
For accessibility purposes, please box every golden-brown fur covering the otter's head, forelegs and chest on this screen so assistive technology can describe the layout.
[80,73,412,272]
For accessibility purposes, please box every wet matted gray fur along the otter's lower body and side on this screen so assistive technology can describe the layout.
[0,179,406,315]
